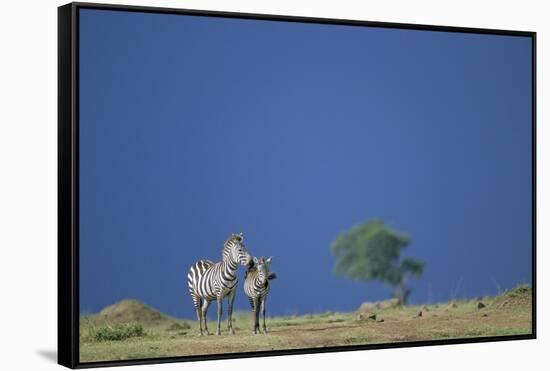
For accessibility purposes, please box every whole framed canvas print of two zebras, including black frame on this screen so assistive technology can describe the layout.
[58,3,536,368]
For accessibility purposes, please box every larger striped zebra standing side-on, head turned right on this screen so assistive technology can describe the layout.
[187,233,251,336]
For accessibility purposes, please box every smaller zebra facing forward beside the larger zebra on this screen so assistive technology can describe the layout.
[244,257,277,334]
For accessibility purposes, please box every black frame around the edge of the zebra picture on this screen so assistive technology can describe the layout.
[58,3,537,368]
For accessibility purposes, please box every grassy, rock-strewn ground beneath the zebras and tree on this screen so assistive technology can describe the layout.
[80,286,532,362]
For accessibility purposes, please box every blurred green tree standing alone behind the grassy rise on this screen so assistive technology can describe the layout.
[331,219,424,305]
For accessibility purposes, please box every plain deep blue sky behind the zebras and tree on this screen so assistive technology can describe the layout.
[80,10,532,317]
